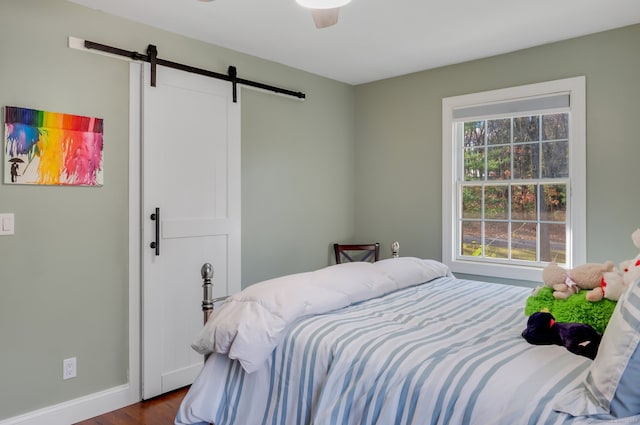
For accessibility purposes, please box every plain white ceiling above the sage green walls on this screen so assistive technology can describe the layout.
[70,0,640,84]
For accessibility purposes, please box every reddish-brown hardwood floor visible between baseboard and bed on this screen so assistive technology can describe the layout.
[75,387,188,425]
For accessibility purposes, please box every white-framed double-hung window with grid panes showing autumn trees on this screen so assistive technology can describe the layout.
[442,77,586,282]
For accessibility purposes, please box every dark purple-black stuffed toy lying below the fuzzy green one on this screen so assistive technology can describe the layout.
[522,312,602,359]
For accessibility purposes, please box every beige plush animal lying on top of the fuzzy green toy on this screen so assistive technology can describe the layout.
[542,261,614,300]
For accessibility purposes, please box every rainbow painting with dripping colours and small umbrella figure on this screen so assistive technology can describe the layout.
[4,106,103,186]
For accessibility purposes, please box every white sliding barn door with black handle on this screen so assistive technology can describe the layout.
[141,64,241,399]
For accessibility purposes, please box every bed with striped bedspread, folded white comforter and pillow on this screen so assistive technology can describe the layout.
[176,257,640,425]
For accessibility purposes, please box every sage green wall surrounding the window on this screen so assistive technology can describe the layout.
[355,25,640,284]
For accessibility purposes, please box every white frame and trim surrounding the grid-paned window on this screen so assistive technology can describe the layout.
[442,76,587,282]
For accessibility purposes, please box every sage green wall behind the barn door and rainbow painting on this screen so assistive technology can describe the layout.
[0,0,355,421]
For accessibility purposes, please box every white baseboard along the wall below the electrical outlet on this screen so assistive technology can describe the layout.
[0,384,139,425]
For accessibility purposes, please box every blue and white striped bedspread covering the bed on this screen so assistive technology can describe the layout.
[176,277,591,425]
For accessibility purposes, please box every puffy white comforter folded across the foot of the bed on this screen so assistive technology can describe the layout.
[192,257,450,373]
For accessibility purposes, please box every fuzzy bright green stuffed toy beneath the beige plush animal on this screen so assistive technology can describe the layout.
[524,286,616,333]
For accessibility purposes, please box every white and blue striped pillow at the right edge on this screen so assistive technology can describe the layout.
[554,279,640,419]
